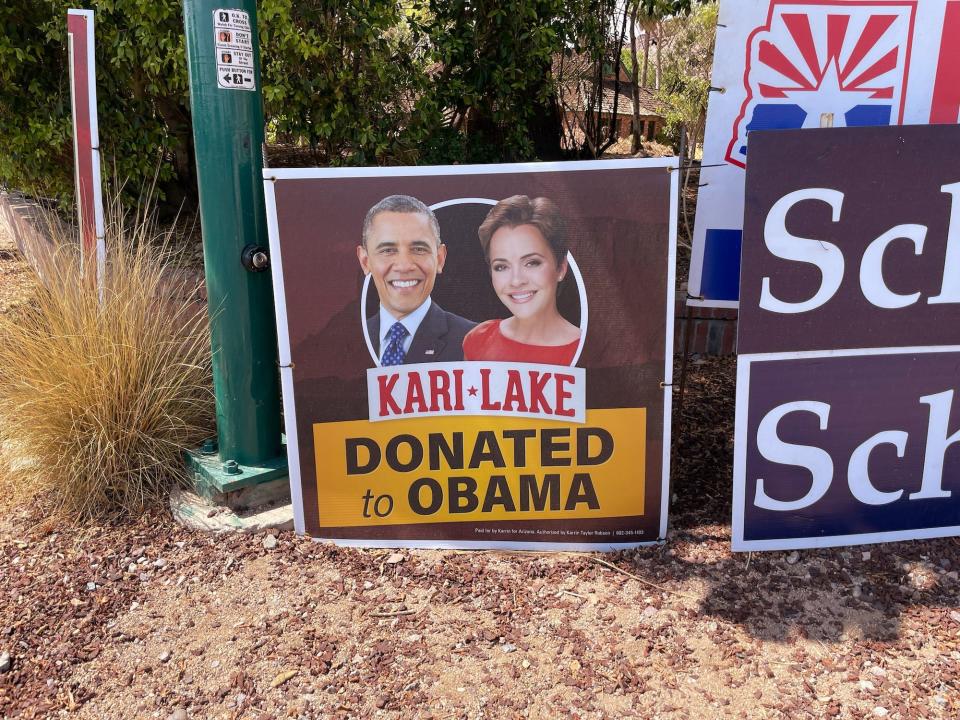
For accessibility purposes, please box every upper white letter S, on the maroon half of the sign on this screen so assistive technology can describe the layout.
[760,188,843,314]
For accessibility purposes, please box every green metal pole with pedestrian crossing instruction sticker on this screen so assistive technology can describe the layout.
[183,0,286,491]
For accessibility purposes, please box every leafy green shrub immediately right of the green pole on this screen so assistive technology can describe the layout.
[258,0,426,165]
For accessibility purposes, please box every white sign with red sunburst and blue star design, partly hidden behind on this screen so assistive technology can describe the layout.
[689,0,960,307]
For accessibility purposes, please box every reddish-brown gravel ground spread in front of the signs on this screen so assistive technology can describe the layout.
[0,210,960,720]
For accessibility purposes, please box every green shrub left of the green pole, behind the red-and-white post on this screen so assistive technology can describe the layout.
[0,0,193,205]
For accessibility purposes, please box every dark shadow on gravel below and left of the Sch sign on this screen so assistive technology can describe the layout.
[609,357,960,643]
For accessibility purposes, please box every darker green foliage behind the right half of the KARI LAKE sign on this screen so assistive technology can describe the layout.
[418,0,614,162]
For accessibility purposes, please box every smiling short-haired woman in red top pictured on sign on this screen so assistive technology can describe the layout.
[463,195,580,365]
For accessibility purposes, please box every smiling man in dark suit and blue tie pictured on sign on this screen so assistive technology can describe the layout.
[357,195,476,366]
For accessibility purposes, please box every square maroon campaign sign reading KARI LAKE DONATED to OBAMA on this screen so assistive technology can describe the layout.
[264,159,677,550]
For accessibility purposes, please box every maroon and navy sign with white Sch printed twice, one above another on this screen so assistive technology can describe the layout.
[733,125,960,550]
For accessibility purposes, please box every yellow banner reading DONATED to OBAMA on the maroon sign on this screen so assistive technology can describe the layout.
[313,408,647,527]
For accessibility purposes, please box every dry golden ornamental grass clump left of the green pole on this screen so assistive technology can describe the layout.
[0,205,213,520]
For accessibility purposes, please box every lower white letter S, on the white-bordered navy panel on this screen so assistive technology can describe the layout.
[753,400,833,511]
